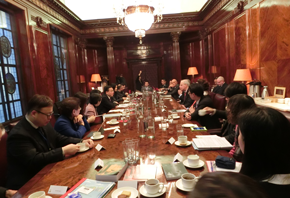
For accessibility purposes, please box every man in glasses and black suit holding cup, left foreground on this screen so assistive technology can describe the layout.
[6,94,94,189]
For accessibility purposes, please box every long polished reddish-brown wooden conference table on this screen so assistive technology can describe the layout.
[14,98,229,198]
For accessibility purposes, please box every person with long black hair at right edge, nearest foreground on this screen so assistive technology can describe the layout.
[238,107,290,198]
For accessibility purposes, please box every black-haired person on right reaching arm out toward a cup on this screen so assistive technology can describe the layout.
[204,82,247,144]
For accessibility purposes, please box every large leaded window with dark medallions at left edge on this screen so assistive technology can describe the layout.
[0,10,23,122]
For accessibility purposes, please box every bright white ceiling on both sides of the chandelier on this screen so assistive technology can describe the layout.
[60,0,207,20]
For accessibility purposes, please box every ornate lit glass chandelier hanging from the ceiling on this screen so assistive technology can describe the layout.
[114,0,164,44]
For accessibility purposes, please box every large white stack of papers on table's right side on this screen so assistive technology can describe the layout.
[192,135,233,151]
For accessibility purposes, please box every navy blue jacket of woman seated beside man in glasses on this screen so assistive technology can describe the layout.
[54,115,90,138]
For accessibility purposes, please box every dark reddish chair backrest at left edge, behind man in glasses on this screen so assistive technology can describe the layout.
[0,133,8,186]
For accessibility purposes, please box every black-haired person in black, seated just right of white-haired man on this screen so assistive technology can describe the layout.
[185,83,221,129]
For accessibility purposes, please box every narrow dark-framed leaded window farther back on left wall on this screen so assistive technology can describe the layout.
[52,33,69,101]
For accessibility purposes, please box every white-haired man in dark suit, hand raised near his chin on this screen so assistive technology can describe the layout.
[178,79,193,109]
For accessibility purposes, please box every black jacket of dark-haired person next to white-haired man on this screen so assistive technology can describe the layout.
[191,96,221,129]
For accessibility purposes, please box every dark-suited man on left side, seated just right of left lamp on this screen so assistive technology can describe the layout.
[97,86,118,114]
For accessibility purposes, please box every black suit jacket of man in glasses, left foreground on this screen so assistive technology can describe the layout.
[7,117,81,190]
